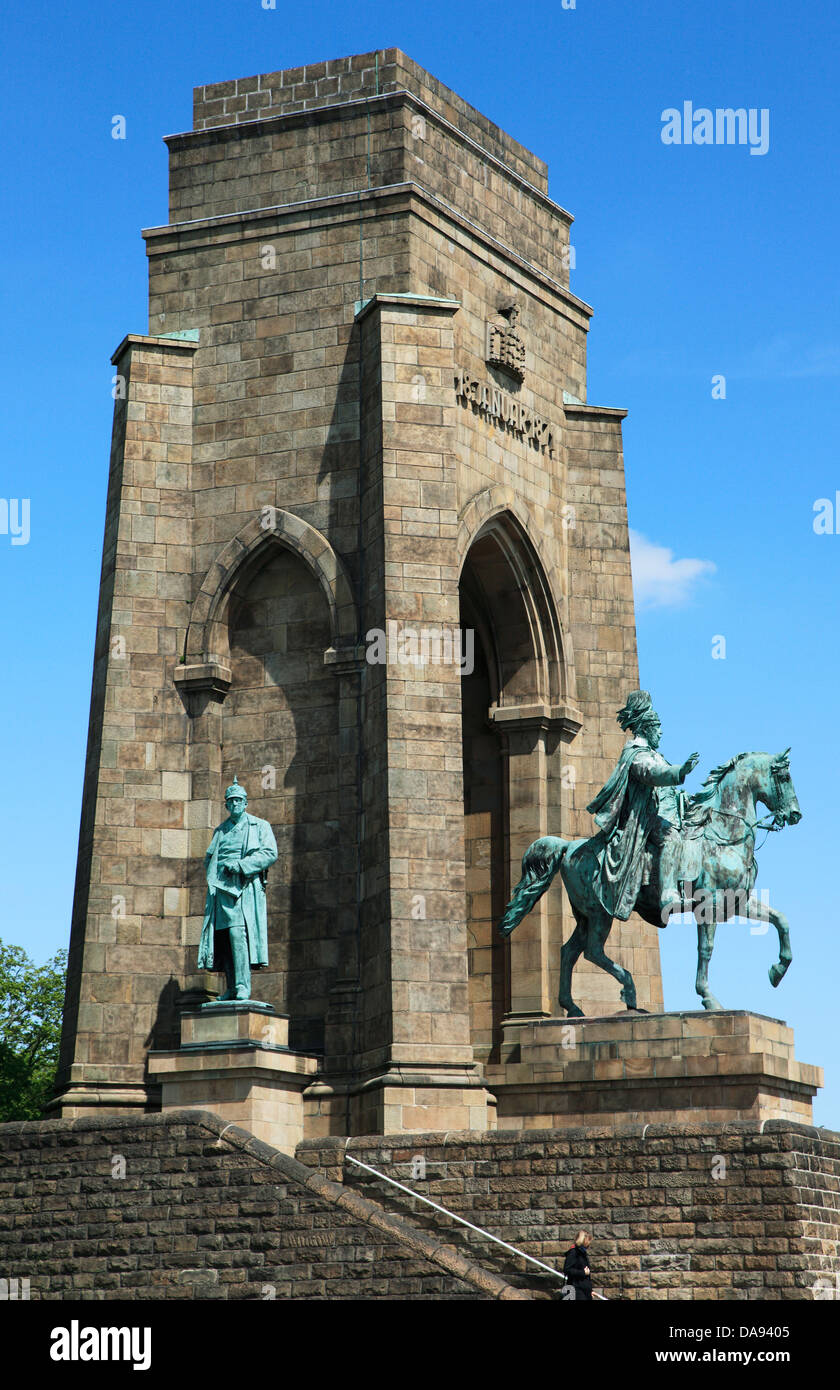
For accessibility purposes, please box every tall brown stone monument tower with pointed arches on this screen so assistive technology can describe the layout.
[57,49,661,1134]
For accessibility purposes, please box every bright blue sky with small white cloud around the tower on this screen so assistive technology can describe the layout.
[0,0,840,1129]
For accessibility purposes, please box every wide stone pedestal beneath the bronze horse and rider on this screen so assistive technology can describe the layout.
[487,1011,823,1129]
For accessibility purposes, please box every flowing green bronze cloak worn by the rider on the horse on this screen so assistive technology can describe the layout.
[587,738,680,922]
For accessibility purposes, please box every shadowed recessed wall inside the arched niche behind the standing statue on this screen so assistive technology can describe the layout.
[221,545,339,1052]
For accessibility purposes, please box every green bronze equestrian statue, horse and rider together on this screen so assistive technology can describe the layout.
[499,691,801,1017]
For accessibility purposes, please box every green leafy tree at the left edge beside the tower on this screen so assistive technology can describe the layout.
[0,941,67,1123]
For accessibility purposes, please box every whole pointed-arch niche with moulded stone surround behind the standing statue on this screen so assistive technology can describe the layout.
[175,509,356,1054]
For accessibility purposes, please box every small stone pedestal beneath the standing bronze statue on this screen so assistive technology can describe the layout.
[149,999,318,1154]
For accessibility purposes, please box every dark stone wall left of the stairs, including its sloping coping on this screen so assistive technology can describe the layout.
[0,1111,533,1301]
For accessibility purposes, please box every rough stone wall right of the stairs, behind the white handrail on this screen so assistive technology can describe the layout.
[298,1120,840,1301]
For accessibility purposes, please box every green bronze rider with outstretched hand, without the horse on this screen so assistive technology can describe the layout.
[587,691,700,926]
